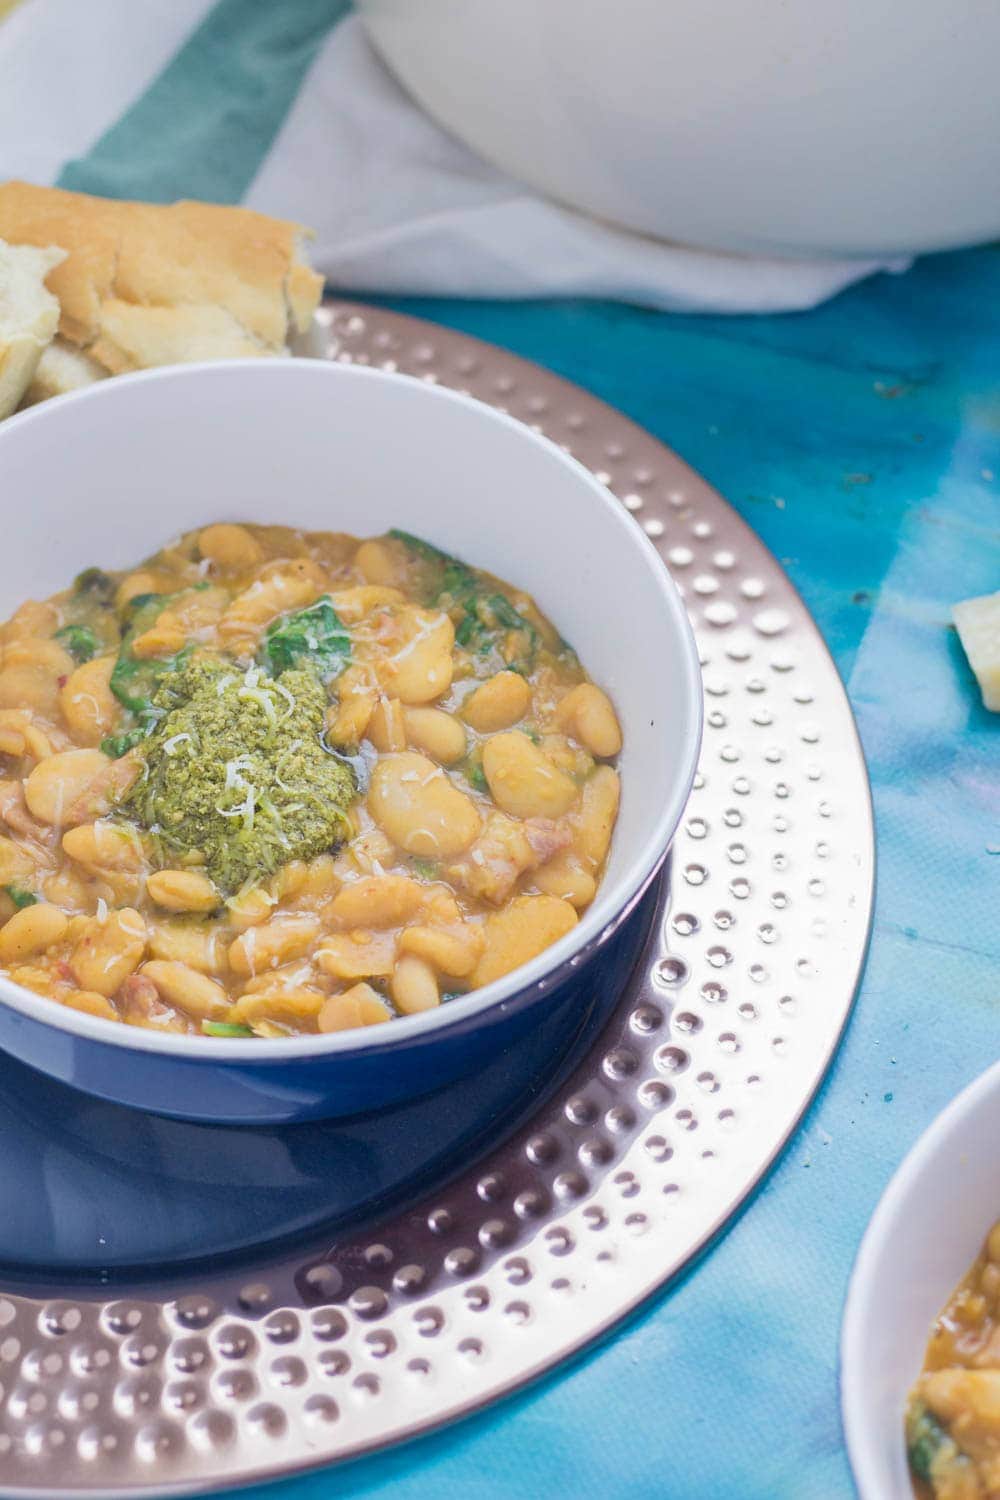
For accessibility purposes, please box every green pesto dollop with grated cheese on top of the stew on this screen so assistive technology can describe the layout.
[121,657,355,896]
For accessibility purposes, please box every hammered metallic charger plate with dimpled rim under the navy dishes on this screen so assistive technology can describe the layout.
[0,303,873,1500]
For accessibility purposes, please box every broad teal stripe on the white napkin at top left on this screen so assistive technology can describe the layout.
[58,0,351,203]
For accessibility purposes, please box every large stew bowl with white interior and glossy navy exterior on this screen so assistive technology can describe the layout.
[0,360,702,1122]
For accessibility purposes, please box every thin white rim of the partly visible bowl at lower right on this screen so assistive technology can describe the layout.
[840,1062,1000,1500]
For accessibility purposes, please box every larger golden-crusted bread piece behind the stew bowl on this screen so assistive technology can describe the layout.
[0,182,322,375]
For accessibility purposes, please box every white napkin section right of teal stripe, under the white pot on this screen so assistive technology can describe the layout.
[247,18,909,312]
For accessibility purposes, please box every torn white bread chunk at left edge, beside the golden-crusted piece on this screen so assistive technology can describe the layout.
[0,240,66,419]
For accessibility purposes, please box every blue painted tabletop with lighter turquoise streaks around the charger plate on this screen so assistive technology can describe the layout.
[197,249,1000,1500]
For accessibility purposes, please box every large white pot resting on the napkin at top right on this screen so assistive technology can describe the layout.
[358,0,1000,255]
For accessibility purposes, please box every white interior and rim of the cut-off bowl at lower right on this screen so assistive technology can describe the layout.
[841,1062,1000,1500]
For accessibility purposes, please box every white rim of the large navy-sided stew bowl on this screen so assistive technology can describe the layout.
[0,360,703,1065]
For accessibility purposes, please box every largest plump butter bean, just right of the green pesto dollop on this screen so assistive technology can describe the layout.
[369,741,482,860]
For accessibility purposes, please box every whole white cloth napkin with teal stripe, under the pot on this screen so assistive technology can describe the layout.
[0,0,907,312]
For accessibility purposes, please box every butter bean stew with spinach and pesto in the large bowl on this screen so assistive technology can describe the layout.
[0,524,622,1037]
